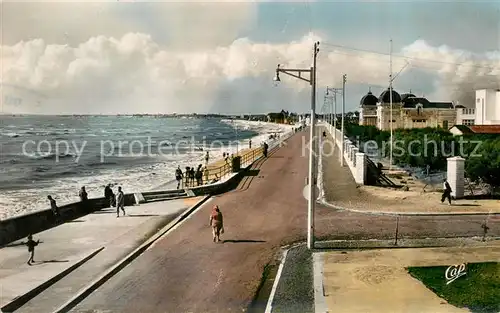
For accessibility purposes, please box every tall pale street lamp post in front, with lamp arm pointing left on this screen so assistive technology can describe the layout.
[274,42,319,249]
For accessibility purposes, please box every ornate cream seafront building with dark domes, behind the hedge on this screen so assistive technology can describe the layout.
[359,89,458,130]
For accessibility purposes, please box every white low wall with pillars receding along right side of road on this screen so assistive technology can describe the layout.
[318,122,368,185]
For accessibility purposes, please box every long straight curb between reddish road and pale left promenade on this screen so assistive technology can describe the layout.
[54,195,211,313]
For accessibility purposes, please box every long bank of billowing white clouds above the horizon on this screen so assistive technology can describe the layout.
[1,33,500,113]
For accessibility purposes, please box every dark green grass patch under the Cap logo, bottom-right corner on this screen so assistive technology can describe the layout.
[408,262,500,313]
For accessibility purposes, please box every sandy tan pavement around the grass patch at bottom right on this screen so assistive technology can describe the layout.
[315,241,500,313]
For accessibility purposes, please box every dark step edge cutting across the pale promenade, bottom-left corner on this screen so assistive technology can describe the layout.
[0,247,104,312]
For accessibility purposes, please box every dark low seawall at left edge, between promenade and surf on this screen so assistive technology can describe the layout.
[0,194,135,246]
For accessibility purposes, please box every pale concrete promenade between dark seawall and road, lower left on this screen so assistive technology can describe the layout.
[0,197,201,312]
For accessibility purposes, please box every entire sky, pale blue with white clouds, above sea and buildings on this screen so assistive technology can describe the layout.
[0,0,500,114]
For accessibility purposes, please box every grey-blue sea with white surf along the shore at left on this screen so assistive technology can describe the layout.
[0,116,291,220]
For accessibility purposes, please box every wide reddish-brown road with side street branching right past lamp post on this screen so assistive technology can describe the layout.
[68,133,498,313]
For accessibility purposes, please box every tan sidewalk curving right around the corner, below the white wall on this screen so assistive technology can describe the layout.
[320,127,500,215]
